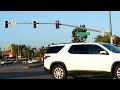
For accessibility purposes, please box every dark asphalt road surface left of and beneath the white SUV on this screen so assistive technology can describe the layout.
[0,64,112,79]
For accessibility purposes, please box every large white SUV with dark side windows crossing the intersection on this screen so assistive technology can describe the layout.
[44,43,120,79]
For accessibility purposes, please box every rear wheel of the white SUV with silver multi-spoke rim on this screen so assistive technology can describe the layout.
[52,65,67,79]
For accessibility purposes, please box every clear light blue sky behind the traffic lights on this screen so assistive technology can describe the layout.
[0,11,120,48]
